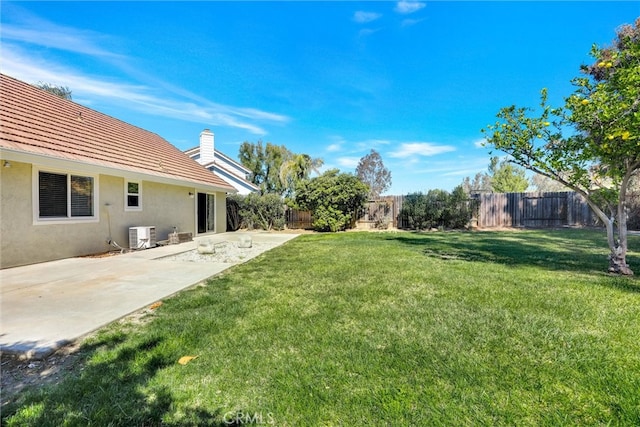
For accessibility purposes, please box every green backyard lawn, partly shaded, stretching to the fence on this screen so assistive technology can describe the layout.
[2,230,640,426]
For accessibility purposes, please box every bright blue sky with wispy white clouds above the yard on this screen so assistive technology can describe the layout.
[0,1,640,194]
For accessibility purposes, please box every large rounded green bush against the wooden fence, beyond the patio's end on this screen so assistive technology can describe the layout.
[295,169,369,232]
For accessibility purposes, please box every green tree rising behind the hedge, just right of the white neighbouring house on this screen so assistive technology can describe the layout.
[238,141,293,195]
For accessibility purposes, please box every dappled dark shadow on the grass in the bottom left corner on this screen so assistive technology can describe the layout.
[2,318,239,427]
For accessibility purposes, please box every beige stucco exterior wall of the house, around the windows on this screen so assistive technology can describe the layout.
[0,161,226,268]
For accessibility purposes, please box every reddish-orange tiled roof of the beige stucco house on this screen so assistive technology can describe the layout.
[0,74,236,192]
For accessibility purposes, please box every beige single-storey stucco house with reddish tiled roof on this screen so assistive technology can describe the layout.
[0,74,236,268]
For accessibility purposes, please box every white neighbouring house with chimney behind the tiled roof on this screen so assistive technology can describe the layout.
[185,129,260,194]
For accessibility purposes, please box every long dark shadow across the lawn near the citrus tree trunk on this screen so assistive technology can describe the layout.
[387,230,640,292]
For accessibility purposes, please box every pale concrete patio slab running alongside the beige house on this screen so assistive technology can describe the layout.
[0,232,297,358]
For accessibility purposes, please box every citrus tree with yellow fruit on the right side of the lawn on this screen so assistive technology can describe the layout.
[483,18,640,275]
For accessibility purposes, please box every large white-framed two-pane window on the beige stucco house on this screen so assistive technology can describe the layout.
[37,171,96,220]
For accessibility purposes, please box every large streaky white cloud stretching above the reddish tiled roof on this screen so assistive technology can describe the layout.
[0,6,290,135]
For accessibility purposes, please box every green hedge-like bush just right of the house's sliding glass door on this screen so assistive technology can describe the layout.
[229,193,286,230]
